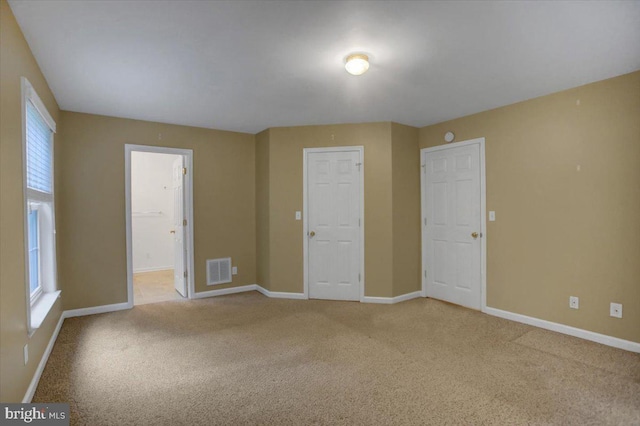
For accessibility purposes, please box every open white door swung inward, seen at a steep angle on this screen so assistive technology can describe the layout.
[172,156,187,297]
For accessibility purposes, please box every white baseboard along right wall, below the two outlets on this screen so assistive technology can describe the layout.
[484,307,640,353]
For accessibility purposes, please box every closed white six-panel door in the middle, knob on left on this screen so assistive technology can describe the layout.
[307,151,362,300]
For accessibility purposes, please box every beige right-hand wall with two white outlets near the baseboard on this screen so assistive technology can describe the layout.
[420,72,640,342]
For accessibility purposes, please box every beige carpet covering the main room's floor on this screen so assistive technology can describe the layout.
[34,292,640,425]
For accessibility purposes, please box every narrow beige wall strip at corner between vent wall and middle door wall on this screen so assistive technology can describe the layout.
[256,129,271,290]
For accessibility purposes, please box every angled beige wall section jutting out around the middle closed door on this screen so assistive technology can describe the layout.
[256,122,421,297]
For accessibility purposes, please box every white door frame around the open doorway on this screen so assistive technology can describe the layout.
[124,144,195,308]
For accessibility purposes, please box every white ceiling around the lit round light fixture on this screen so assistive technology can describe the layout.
[9,0,640,133]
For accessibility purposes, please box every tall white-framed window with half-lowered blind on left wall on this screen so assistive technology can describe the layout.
[22,78,60,332]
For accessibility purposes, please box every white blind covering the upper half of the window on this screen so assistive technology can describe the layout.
[26,101,53,194]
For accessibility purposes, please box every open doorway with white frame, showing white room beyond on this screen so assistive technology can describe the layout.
[125,145,193,306]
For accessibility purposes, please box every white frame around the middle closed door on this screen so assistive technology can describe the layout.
[302,145,366,302]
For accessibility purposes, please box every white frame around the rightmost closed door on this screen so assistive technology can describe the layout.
[420,138,487,312]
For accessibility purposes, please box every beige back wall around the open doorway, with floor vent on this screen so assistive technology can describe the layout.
[58,112,256,309]
